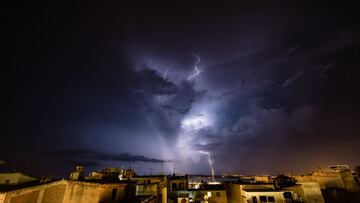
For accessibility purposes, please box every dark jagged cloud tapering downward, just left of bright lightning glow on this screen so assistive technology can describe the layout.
[133,66,206,143]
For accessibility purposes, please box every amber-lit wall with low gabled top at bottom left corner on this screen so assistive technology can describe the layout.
[3,180,126,203]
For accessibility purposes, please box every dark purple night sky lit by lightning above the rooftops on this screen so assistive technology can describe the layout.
[0,1,360,175]
